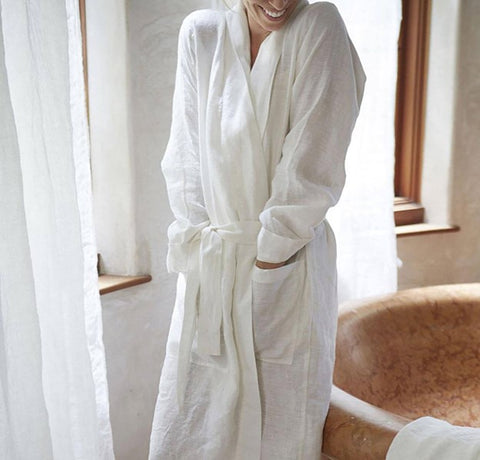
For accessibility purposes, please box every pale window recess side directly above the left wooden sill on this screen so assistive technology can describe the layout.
[85,0,137,274]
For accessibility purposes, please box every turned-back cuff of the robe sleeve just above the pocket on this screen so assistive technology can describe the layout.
[257,227,310,263]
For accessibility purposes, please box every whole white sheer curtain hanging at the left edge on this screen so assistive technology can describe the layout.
[0,0,113,460]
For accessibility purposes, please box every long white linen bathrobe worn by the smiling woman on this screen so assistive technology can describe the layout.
[150,0,365,460]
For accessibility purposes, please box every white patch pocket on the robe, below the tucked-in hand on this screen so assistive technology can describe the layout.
[252,260,304,364]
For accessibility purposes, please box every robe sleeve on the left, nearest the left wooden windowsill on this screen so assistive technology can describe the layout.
[161,15,209,272]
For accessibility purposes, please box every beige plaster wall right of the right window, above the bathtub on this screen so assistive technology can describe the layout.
[398,0,480,289]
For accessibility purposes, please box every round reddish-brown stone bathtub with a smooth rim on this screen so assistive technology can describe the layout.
[323,283,480,460]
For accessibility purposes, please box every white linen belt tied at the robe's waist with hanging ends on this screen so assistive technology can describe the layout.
[177,220,261,407]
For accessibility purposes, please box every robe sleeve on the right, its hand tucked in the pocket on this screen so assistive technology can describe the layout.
[257,2,365,263]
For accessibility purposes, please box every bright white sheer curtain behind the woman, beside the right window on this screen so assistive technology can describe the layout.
[322,0,402,302]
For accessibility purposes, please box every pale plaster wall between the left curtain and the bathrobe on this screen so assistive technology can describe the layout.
[87,0,209,460]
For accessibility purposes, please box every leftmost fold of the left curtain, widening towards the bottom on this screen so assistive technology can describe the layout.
[0,9,52,459]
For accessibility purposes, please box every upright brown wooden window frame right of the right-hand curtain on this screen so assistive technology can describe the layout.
[395,0,431,203]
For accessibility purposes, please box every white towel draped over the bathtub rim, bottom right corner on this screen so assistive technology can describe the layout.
[386,417,480,460]
